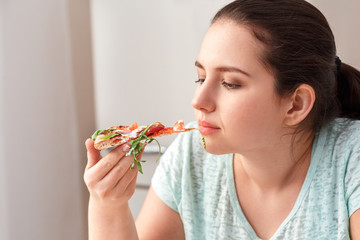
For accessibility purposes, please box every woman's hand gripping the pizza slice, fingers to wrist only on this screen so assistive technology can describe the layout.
[84,139,141,207]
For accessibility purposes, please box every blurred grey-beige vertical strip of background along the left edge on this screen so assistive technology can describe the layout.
[0,0,95,240]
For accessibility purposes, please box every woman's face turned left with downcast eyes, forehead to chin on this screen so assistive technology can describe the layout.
[192,21,286,154]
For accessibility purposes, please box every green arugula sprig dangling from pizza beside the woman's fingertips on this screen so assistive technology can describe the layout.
[127,124,161,174]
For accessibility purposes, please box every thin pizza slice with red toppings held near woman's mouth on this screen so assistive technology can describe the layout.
[91,120,194,150]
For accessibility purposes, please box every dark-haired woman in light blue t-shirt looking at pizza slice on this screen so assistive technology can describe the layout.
[84,0,360,239]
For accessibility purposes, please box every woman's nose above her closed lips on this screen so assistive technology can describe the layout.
[191,82,216,112]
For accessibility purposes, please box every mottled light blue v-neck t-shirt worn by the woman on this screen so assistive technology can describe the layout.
[152,119,360,240]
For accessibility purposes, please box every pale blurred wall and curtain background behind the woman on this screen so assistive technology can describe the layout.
[0,0,360,240]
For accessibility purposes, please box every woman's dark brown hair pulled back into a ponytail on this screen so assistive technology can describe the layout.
[211,0,360,130]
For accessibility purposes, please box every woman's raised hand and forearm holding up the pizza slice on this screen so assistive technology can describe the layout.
[84,139,141,240]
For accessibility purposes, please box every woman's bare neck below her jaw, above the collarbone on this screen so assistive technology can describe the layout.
[234,130,314,192]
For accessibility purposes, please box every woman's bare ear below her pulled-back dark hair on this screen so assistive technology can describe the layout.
[284,84,315,126]
